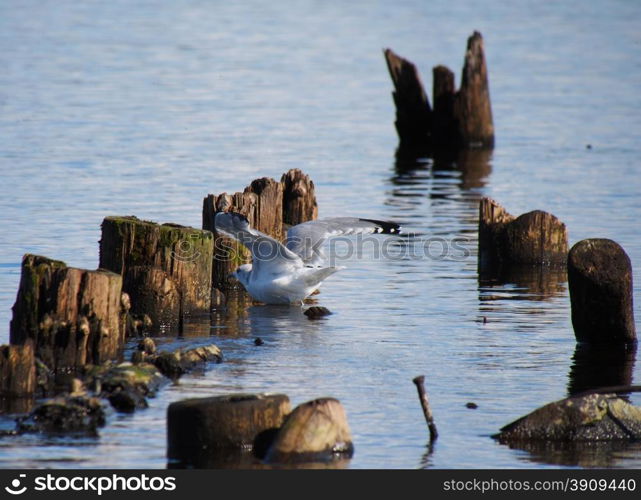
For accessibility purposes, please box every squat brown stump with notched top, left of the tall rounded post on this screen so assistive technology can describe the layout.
[478,198,568,267]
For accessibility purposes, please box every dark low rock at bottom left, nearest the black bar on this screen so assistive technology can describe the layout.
[17,396,105,435]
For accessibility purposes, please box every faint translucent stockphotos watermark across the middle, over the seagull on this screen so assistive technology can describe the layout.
[208,234,472,266]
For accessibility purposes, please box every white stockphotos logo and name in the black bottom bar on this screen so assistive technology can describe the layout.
[4,474,176,496]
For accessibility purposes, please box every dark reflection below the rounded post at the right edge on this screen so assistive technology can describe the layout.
[568,343,637,396]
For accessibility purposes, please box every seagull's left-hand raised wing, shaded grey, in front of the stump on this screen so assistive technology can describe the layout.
[214,212,303,276]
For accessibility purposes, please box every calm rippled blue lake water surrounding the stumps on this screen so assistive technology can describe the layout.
[0,0,641,468]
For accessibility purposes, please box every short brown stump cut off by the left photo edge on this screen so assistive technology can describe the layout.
[0,339,36,398]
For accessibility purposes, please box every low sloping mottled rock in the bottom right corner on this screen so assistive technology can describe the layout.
[493,394,641,443]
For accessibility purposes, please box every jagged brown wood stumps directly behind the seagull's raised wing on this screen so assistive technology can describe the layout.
[203,169,318,293]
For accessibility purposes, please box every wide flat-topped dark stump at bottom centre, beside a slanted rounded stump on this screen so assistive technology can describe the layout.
[167,394,291,466]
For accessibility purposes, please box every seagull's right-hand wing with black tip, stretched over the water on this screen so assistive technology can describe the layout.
[285,217,401,266]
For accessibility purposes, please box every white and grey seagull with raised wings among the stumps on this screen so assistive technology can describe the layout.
[214,212,400,304]
